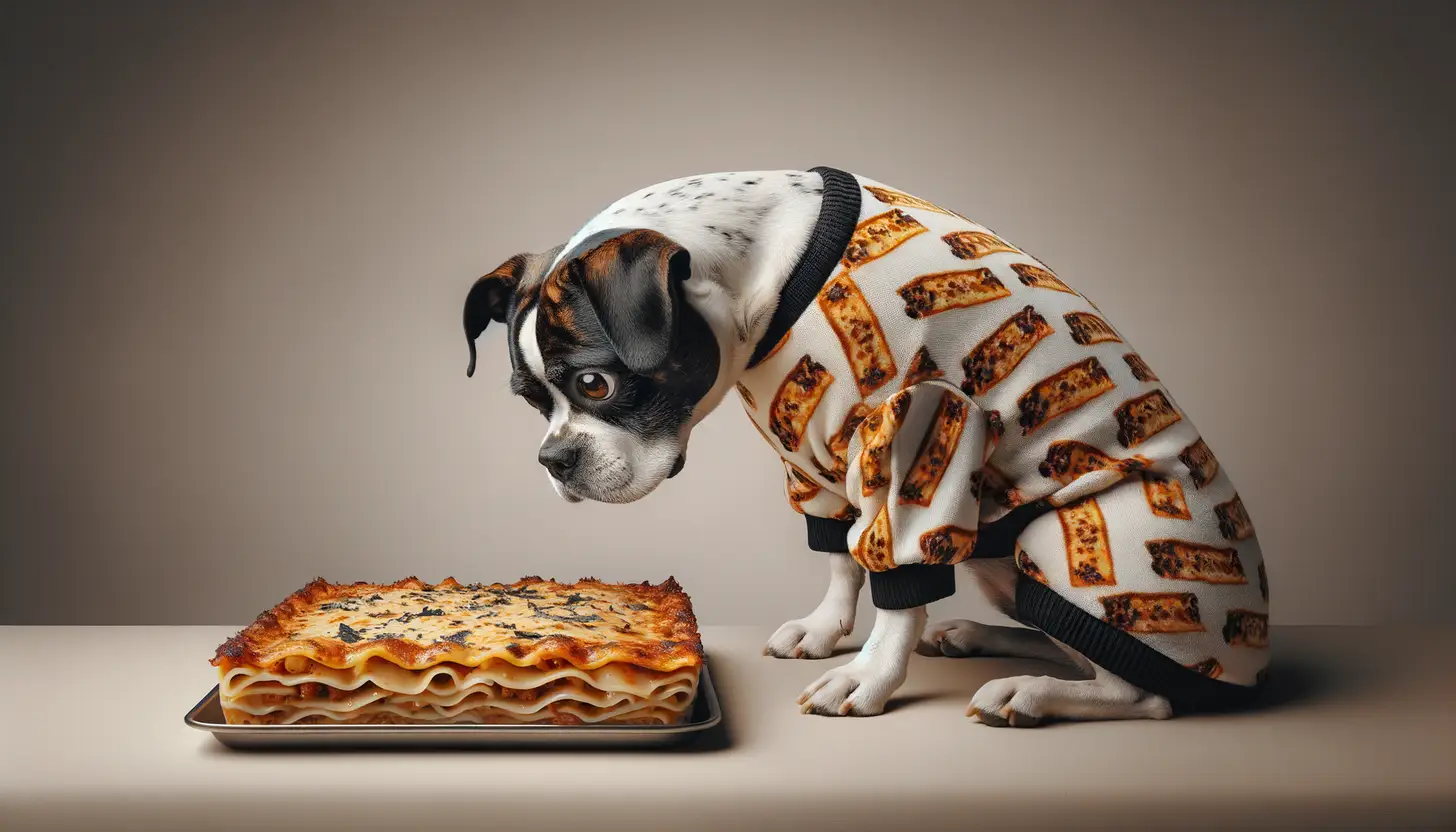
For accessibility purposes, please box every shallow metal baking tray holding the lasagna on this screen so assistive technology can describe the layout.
[183,663,722,750]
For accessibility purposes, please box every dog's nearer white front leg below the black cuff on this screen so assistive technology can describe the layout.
[799,606,926,717]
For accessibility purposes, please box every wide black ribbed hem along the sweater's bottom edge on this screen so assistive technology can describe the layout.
[1019,567,1264,713]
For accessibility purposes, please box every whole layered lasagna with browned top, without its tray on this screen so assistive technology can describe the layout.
[213,577,703,726]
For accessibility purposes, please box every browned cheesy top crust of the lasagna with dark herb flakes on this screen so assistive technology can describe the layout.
[213,576,703,672]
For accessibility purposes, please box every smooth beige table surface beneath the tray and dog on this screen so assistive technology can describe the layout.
[0,627,1456,832]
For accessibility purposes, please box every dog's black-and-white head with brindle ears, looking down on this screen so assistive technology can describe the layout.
[464,229,721,503]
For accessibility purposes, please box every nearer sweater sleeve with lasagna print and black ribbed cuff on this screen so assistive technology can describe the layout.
[844,380,986,609]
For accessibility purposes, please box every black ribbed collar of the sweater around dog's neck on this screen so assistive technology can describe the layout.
[748,168,859,367]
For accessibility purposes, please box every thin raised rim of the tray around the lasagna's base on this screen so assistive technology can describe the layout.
[182,659,722,740]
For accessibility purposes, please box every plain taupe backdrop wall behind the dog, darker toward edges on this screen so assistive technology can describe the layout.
[0,3,1456,624]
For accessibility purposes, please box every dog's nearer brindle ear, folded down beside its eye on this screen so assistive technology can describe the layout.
[566,229,692,373]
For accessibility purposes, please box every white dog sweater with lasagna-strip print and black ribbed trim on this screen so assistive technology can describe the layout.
[738,168,1268,705]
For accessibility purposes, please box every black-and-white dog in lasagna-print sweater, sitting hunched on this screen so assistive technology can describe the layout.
[463,168,1268,727]
